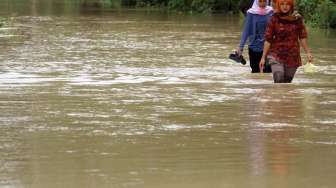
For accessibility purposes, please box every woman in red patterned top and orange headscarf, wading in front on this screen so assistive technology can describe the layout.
[259,0,313,83]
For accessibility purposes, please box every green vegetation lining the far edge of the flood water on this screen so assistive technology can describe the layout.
[0,0,336,28]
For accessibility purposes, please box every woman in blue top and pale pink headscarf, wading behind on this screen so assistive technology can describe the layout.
[237,0,273,73]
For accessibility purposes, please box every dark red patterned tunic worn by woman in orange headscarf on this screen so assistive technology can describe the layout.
[265,14,307,67]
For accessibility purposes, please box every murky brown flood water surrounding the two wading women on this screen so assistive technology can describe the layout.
[0,1,336,188]
